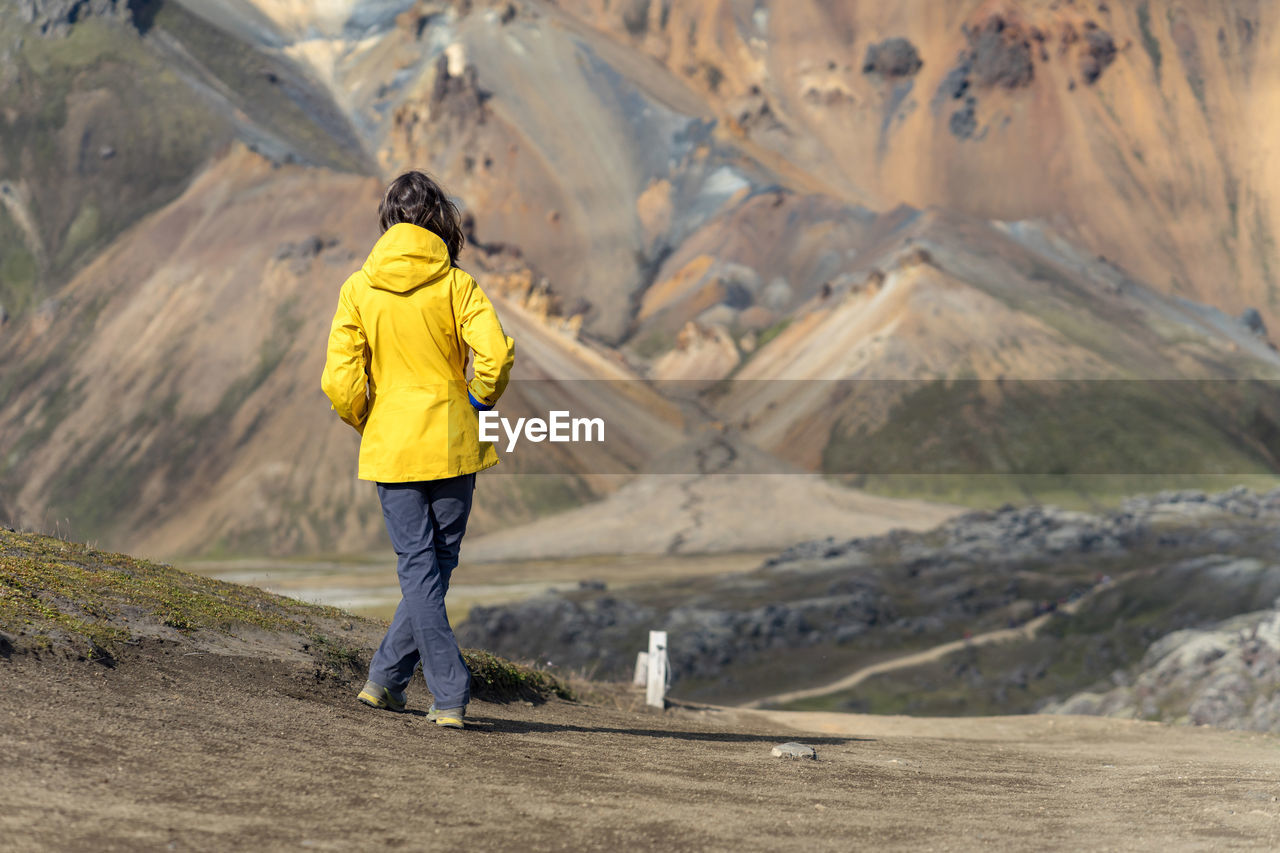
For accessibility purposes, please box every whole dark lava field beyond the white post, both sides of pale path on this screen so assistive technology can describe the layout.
[460,489,1280,715]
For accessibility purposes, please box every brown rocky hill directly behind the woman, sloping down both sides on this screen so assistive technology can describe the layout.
[0,147,681,553]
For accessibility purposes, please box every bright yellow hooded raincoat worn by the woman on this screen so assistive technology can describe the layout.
[321,223,516,483]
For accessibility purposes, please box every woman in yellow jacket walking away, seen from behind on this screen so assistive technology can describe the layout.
[321,172,515,729]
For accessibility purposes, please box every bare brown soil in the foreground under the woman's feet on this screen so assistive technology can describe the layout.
[0,642,1280,850]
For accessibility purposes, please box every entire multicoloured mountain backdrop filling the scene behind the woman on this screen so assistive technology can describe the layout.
[0,0,1280,553]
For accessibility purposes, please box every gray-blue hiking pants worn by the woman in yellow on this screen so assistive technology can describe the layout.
[369,474,476,708]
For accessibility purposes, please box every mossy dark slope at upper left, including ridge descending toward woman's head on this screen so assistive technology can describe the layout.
[0,3,371,310]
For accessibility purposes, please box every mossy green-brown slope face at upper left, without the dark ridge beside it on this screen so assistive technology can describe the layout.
[0,18,229,283]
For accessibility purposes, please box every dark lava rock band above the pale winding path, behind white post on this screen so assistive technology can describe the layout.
[456,488,1280,701]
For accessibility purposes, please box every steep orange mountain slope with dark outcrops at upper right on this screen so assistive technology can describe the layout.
[557,0,1280,338]
